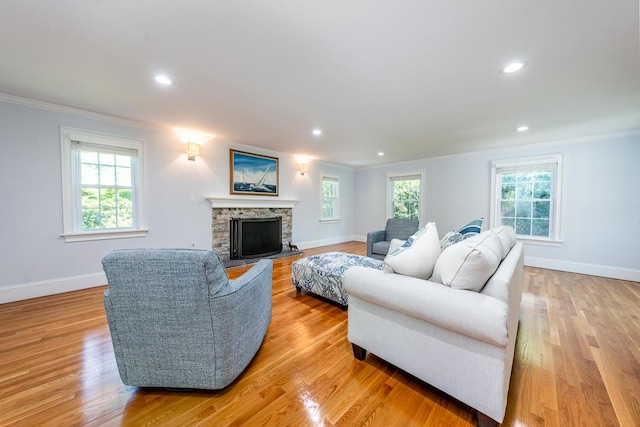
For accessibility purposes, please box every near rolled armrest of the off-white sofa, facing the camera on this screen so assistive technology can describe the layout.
[343,267,509,348]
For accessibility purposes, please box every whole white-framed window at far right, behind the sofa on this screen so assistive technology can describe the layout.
[491,155,562,242]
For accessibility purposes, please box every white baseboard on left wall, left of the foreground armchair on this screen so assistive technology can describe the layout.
[0,273,107,304]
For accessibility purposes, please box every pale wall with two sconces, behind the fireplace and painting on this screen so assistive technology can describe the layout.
[0,97,354,303]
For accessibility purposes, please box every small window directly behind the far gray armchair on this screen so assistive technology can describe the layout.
[387,174,422,220]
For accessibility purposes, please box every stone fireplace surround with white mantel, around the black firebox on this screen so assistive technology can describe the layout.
[208,197,298,261]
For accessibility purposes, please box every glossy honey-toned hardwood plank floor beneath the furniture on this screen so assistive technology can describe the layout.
[0,242,640,427]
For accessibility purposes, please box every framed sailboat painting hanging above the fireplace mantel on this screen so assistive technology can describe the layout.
[229,150,279,196]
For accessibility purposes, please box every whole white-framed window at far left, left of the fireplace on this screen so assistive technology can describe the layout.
[62,127,146,242]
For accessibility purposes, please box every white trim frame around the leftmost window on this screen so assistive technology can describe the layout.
[60,126,149,242]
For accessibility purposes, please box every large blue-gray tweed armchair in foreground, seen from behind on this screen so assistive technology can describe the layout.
[102,249,273,390]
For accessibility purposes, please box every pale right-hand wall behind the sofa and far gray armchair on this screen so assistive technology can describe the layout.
[354,132,640,281]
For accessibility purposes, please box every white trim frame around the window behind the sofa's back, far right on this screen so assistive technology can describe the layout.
[489,154,564,246]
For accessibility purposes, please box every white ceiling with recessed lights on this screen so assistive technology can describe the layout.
[0,0,640,167]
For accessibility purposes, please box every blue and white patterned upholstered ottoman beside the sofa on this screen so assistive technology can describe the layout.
[291,252,384,308]
